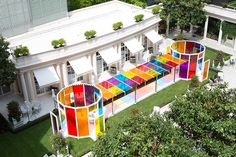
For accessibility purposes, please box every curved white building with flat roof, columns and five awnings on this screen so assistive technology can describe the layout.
[0,0,162,105]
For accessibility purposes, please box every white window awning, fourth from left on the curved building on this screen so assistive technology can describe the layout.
[124,38,144,55]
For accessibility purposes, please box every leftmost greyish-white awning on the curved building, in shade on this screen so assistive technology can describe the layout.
[34,66,60,87]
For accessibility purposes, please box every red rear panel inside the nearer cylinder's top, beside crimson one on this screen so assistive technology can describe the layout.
[74,85,85,106]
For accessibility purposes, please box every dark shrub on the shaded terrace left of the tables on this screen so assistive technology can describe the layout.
[7,101,22,122]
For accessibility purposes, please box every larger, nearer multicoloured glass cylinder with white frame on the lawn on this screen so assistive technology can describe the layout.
[57,84,105,140]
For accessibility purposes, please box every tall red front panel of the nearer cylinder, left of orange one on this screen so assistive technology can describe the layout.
[66,108,77,136]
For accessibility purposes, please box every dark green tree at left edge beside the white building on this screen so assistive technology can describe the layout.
[0,36,16,86]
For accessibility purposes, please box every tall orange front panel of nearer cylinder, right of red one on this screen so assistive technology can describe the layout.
[76,108,89,136]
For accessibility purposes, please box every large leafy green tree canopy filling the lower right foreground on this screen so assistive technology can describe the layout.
[93,85,236,157]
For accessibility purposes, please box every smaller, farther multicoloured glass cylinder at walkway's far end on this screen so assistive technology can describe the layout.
[170,40,206,79]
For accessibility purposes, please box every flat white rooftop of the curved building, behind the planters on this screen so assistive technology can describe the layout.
[8,0,153,54]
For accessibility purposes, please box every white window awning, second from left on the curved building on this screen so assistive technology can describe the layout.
[69,57,93,76]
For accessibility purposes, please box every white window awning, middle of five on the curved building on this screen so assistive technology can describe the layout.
[99,47,121,65]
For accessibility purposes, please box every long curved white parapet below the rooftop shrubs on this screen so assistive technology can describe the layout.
[16,16,160,69]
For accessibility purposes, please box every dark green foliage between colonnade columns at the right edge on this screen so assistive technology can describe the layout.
[222,21,236,40]
